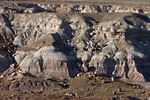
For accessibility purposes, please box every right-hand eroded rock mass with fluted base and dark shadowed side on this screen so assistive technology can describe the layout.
[89,14,149,81]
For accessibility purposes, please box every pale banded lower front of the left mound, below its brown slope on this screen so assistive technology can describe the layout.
[19,47,78,79]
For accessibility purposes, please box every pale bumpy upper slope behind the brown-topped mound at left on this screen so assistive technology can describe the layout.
[12,14,62,47]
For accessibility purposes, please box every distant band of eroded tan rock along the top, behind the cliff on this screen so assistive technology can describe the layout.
[0,2,150,14]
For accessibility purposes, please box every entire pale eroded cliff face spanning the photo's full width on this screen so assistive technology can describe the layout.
[0,4,150,81]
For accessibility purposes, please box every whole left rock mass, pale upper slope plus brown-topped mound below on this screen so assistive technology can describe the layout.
[12,14,78,79]
